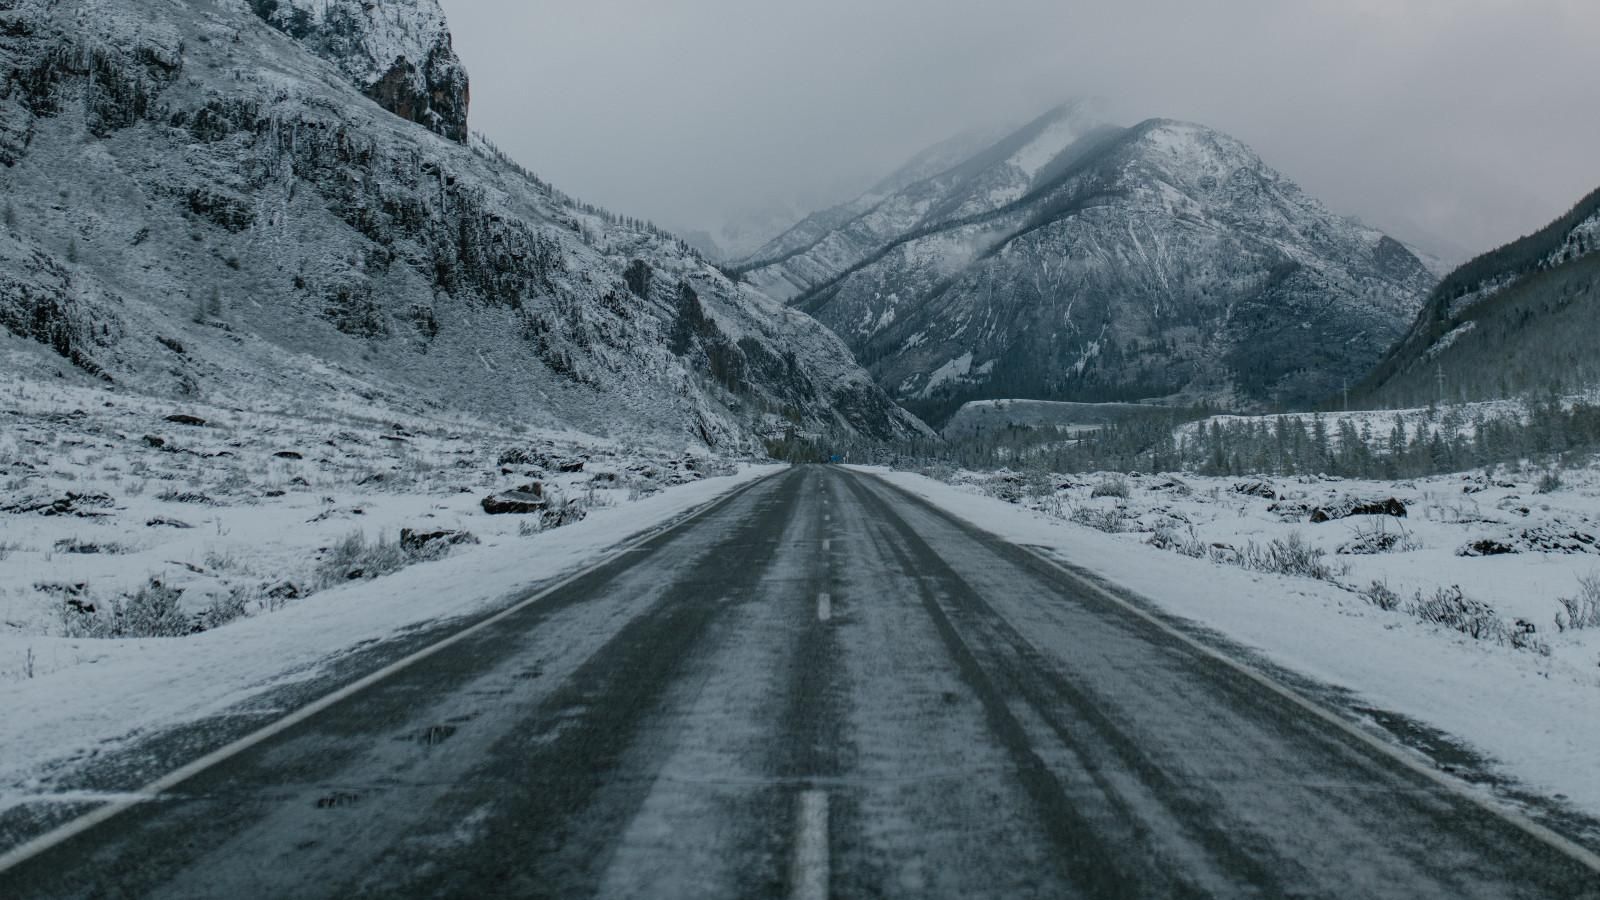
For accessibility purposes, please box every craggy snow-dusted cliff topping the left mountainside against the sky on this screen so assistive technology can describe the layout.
[248,0,472,143]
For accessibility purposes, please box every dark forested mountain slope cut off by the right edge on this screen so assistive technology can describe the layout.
[1360,191,1600,405]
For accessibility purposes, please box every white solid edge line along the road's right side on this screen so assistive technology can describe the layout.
[858,472,1600,873]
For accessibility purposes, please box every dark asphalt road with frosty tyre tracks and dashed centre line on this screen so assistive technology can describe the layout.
[0,466,1600,900]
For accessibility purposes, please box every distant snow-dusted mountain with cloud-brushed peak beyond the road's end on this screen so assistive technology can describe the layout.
[747,106,1434,420]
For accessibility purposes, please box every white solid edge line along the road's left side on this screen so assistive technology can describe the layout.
[0,469,789,873]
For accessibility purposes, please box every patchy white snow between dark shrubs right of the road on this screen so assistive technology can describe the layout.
[862,469,1600,815]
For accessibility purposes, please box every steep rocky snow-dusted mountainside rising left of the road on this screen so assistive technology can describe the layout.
[0,0,922,445]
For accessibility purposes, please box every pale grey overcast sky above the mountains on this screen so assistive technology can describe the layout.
[442,0,1600,253]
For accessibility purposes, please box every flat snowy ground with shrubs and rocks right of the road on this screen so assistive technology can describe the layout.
[872,468,1600,815]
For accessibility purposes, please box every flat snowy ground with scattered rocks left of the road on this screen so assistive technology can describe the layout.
[0,371,770,810]
